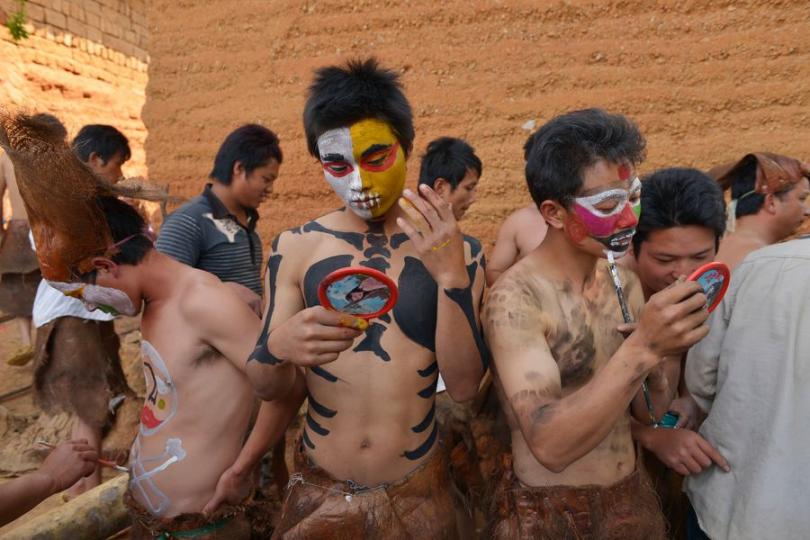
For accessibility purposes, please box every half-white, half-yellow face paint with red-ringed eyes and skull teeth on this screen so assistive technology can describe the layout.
[318,118,406,220]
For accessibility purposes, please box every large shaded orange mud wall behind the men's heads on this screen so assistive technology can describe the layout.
[144,0,810,243]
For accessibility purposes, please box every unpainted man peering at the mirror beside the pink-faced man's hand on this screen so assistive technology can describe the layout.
[621,168,728,538]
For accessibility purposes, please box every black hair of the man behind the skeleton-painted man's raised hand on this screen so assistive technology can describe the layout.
[419,137,483,189]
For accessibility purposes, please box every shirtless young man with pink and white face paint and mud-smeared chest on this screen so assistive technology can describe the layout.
[482,109,708,539]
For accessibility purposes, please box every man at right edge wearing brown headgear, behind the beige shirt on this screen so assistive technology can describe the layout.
[709,152,810,270]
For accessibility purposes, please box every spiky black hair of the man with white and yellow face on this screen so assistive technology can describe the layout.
[304,57,414,159]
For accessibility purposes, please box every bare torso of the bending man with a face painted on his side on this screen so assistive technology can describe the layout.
[130,263,260,516]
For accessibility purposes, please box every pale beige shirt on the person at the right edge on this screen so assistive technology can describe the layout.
[684,238,810,540]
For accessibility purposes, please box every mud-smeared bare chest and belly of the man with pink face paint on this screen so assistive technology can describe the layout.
[495,261,638,485]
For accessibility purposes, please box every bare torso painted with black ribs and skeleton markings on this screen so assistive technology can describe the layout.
[278,214,480,484]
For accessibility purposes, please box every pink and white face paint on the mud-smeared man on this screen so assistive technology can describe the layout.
[573,175,641,255]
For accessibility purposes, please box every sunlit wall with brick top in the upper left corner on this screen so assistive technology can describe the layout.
[0,0,149,176]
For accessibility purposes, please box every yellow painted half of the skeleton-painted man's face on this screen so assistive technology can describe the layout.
[349,118,406,218]
